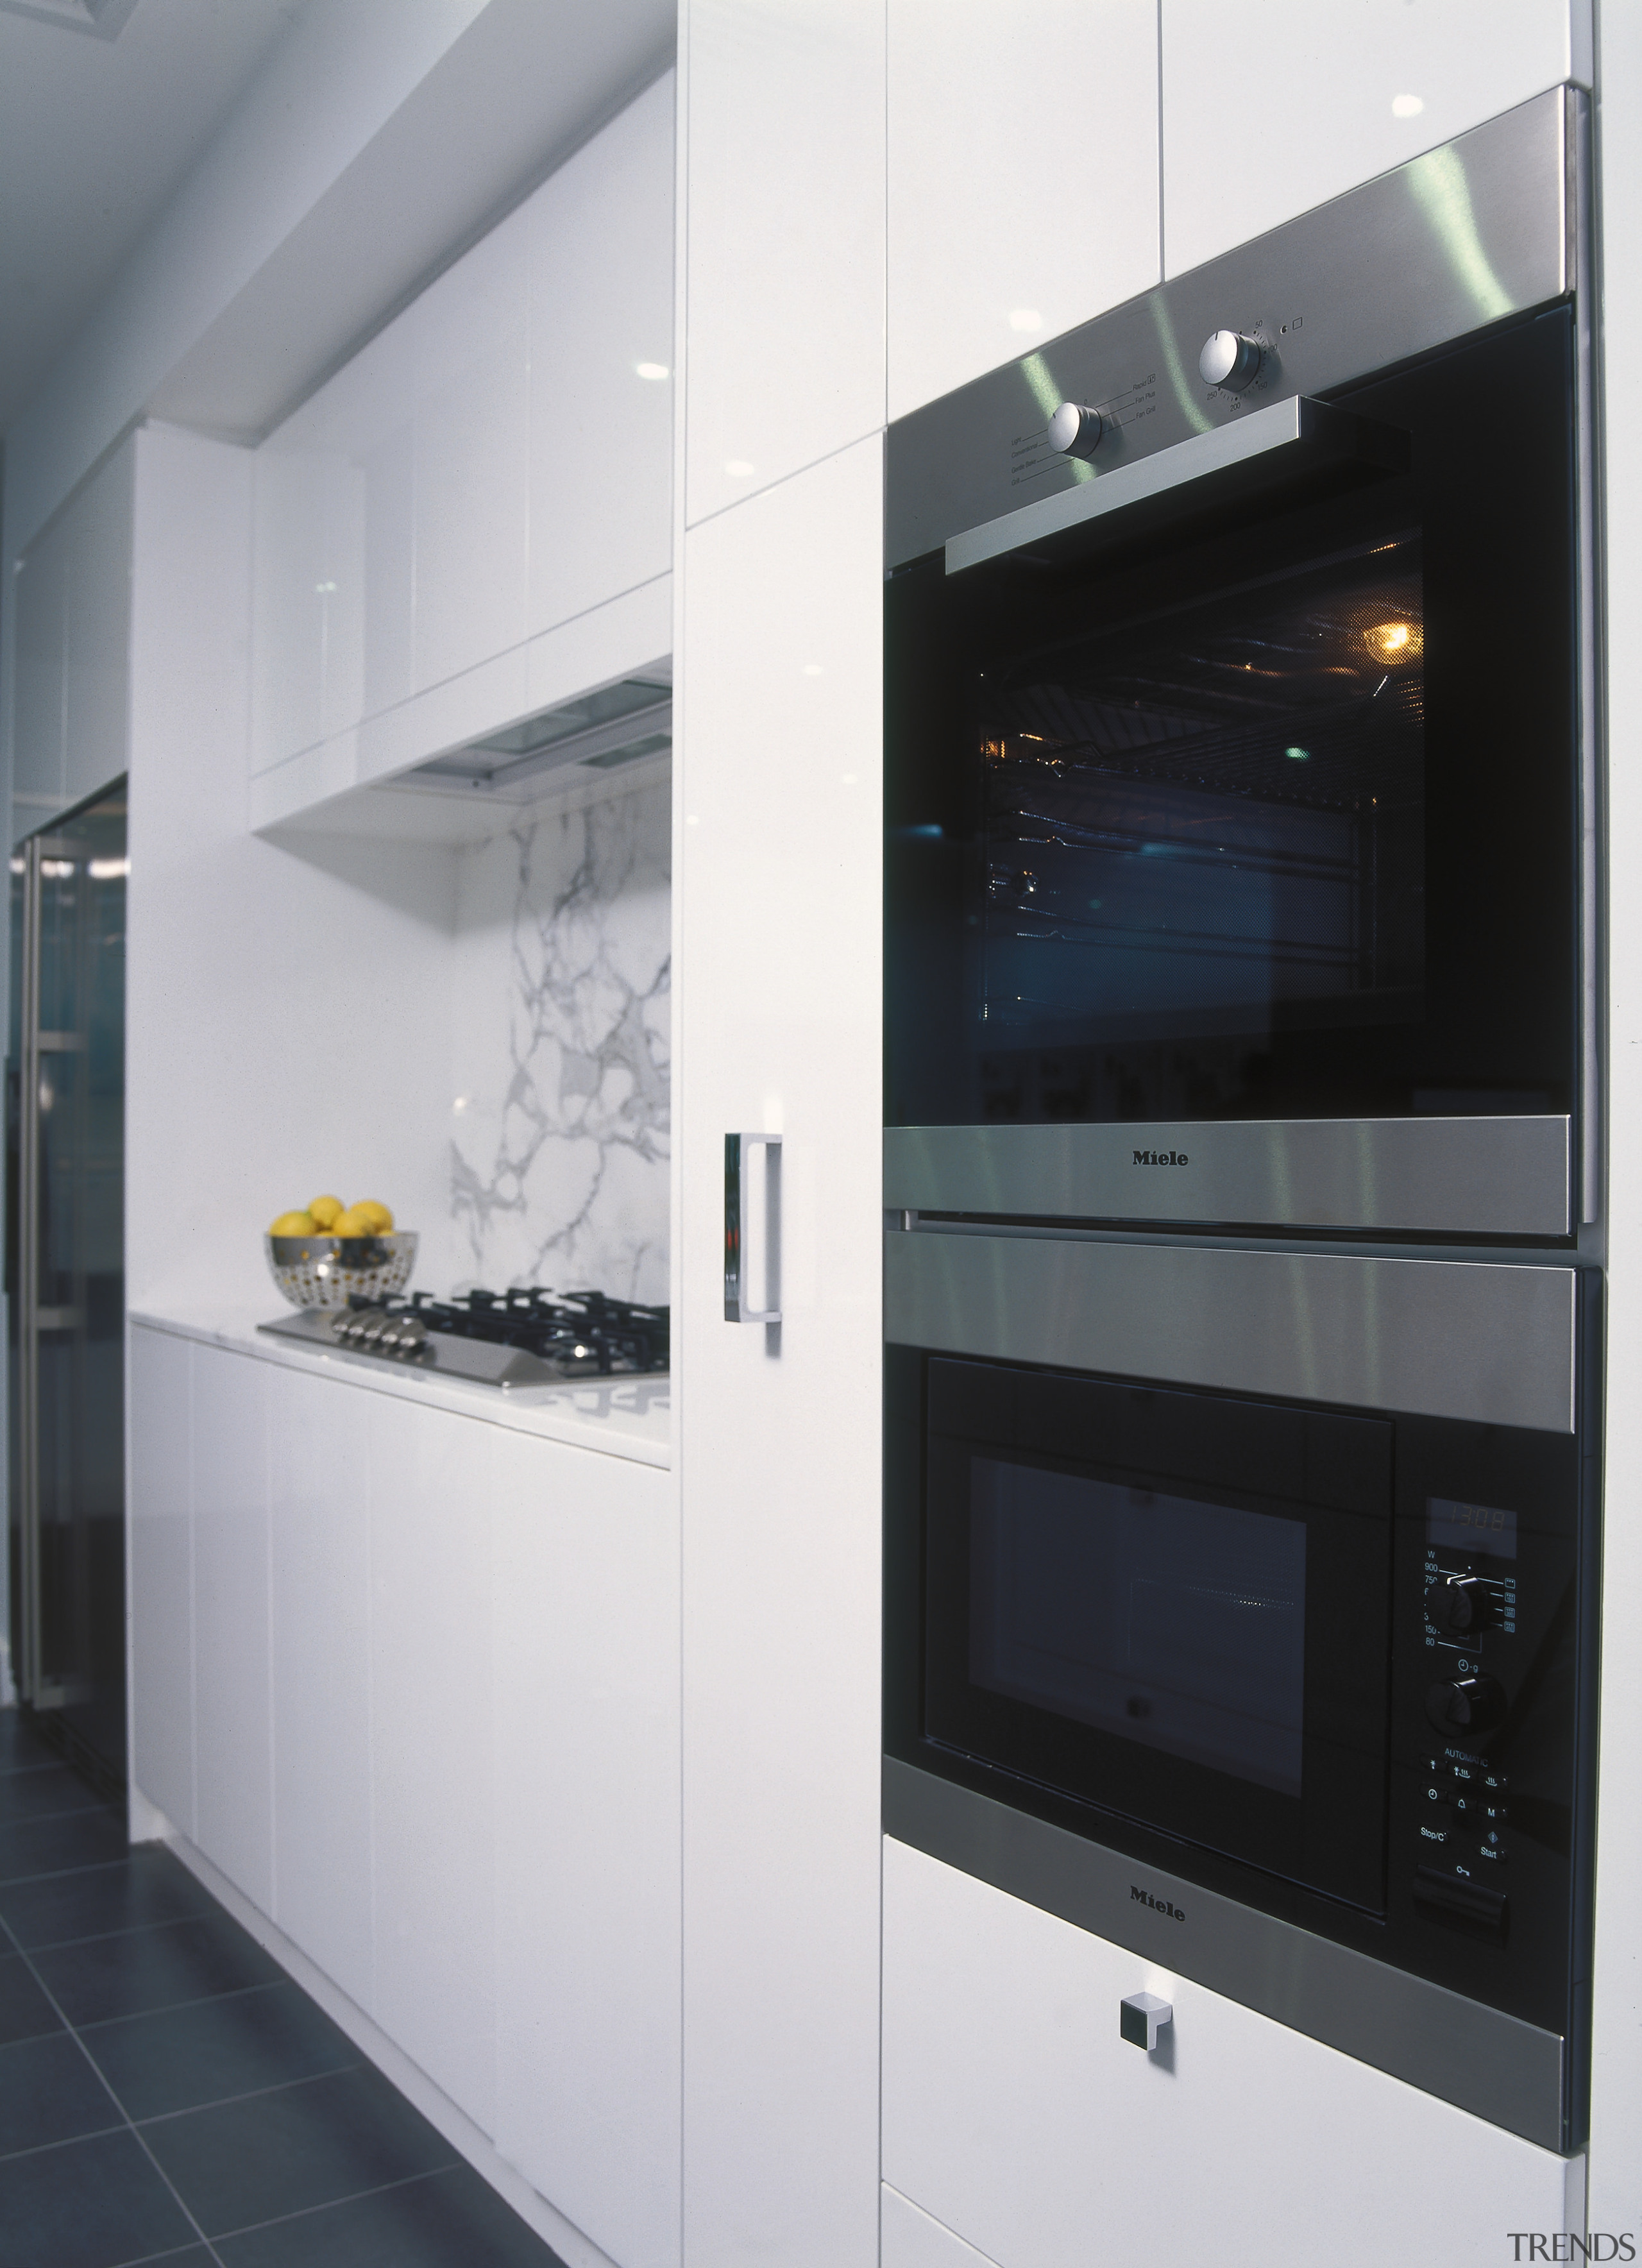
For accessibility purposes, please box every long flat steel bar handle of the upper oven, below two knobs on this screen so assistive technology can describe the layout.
[945,394,1409,574]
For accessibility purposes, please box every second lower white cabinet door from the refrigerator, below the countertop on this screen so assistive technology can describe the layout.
[193,1347,275,1912]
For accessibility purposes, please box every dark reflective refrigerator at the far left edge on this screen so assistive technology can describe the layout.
[7,783,130,1785]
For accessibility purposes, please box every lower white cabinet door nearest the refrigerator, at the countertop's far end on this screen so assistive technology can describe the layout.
[127,1324,195,1837]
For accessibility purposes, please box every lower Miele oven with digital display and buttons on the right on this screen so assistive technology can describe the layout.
[884,1224,1599,2148]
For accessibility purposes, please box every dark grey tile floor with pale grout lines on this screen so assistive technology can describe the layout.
[0,1710,563,2268]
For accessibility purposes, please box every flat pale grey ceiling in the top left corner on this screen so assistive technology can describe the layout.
[0,0,304,433]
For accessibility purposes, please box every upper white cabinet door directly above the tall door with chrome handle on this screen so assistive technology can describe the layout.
[681,0,884,521]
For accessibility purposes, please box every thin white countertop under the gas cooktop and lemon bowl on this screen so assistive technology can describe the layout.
[131,1308,673,1465]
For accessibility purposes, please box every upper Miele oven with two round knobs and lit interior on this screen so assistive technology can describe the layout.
[884,90,1595,1239]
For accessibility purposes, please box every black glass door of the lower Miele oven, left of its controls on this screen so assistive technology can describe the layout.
[923,1358,1392,1914]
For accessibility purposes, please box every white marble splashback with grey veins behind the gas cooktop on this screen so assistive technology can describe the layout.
[435,780,672,1302]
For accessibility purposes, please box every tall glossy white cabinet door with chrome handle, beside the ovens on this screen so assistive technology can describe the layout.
[673,433,882,2268]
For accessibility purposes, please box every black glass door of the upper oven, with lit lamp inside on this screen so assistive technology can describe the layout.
[887,309,1579,1125]
